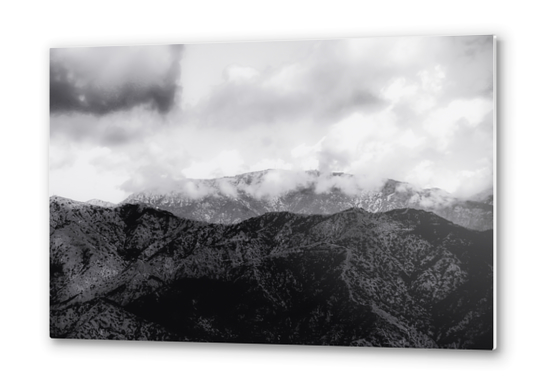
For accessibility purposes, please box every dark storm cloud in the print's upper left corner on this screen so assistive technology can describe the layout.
[50,45,183,115]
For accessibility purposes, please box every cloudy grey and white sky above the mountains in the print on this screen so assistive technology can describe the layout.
[49,36,494,203]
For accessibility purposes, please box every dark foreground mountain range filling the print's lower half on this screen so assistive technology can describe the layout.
[50,197,493,349]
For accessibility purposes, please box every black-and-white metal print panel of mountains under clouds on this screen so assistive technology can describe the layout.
[49,36,495,350]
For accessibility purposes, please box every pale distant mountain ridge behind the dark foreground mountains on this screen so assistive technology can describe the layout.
[123,170,493,230]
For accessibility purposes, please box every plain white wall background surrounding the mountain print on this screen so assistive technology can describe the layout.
[0,0,542,383]
